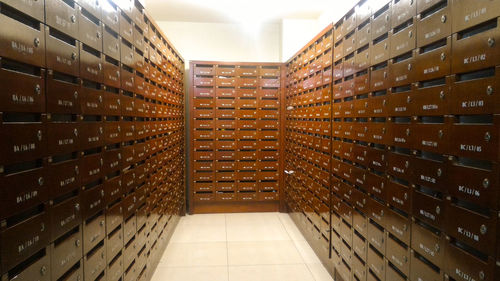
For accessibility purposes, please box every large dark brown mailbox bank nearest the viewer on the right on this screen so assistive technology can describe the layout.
[332,0,500,281]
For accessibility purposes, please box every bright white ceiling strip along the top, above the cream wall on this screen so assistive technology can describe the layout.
[146,0,342,23]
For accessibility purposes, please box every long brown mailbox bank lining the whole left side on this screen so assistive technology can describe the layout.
[0,0,184,281]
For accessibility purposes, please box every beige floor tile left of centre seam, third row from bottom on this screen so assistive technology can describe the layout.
[171,223,226,243]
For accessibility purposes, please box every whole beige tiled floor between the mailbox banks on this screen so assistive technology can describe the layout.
[153,213,332,281]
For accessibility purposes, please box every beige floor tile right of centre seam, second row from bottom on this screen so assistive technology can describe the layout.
[228,241,304,265]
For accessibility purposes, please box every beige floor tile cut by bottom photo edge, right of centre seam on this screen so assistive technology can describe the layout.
[229,264,314,281]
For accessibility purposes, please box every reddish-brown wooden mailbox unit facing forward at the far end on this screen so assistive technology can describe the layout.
[192,62,280,208]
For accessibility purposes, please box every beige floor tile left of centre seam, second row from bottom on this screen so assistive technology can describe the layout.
[159,242,227,266]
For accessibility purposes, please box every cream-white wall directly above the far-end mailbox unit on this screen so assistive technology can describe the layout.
[158,21,281,66]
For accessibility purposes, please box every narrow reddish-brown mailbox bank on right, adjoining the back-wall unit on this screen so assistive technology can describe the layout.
[285,28,333,259]
